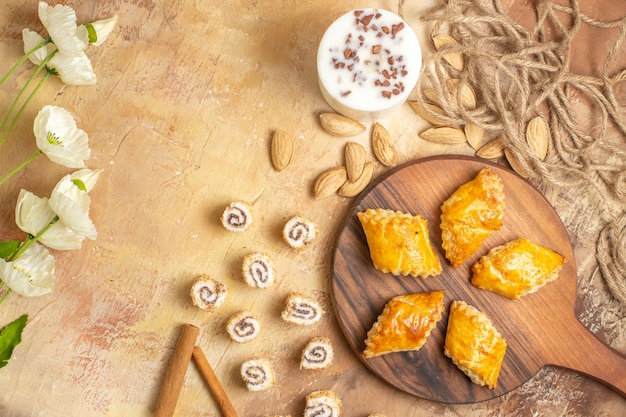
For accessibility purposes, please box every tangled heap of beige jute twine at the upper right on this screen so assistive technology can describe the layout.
[398,0,626,305]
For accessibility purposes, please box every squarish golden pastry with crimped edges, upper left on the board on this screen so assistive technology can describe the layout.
[357,208,441,278]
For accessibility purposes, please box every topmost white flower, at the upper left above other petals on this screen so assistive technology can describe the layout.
[39,1,87,55]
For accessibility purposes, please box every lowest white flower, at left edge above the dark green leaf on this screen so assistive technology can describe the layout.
[0,242,55,297]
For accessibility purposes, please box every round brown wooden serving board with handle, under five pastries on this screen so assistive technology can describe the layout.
[331,156,626,403]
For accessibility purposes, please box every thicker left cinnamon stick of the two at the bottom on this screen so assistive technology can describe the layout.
[154,324,200,417]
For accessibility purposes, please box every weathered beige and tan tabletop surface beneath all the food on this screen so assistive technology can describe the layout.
[0,0,626,417]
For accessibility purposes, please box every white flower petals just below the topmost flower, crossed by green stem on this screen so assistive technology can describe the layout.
[22,29,96,85]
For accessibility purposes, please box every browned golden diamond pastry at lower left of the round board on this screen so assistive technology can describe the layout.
[363,291,444,358]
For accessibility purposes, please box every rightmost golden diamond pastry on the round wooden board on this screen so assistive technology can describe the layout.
[472,238,565,300]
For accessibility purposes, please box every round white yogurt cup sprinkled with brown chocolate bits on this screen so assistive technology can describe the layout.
[317,8,422,121]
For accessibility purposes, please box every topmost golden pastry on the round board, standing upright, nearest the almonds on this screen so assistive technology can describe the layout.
[441,167,504,268]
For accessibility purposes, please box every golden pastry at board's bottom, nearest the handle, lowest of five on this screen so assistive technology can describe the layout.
[444,301,506,389]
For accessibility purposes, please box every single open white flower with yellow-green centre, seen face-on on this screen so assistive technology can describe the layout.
[33,106,91,168]
